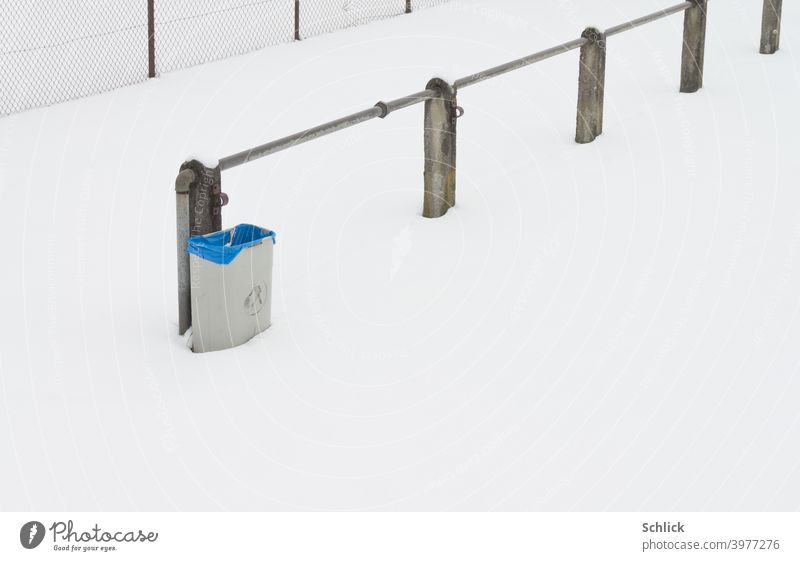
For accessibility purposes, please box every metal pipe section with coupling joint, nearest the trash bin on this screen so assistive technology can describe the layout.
[219,90,439,170]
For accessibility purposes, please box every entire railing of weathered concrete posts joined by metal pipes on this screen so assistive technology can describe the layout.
[175,0,782,334]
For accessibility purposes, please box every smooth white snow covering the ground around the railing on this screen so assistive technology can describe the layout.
[0,0,800,511]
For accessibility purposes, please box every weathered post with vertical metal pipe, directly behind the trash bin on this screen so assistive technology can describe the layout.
[175,160,228,335]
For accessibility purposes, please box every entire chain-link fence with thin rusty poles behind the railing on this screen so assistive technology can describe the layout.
[0,0,448,116]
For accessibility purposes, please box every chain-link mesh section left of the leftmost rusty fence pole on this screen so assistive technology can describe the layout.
[0,0,147,115]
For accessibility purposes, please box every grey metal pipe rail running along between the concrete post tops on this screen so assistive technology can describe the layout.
[219,0,697,170]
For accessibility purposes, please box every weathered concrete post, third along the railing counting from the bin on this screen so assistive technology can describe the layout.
[575,27,606,144]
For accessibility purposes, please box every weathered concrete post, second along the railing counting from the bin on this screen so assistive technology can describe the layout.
[422,78,460,218]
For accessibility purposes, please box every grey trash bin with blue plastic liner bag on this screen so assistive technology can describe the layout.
[187,224,275,353]
